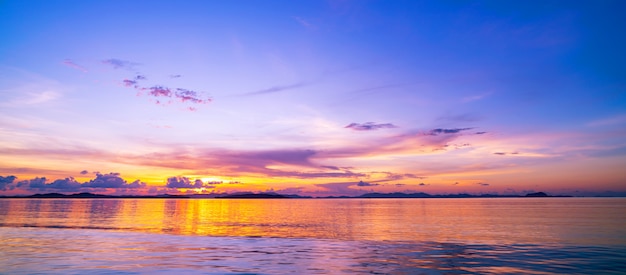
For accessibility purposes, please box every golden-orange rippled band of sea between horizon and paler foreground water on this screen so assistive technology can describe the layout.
[0,198,626,247]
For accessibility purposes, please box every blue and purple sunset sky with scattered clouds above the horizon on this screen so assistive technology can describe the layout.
[0,0,626,196]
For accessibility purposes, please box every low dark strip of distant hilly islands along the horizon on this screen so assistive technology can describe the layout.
[0,192,571,199]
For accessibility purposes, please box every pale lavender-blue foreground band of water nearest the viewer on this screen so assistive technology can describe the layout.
[0,228,626,274]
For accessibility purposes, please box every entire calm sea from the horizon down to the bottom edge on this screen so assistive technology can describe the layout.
[0,198,626,274]
